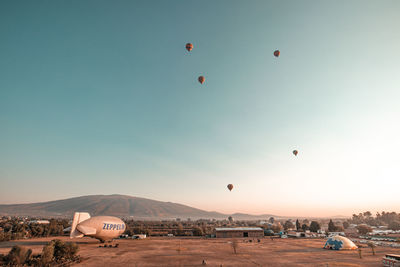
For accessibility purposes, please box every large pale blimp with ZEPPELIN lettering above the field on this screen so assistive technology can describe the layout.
[70,212,125,243]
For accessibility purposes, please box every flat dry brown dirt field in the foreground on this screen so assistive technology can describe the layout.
[0,237,400,267]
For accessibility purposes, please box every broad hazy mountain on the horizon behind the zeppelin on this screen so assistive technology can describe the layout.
[0,195,271,220]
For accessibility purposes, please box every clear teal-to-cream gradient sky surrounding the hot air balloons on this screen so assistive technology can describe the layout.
[0,0,400,216]
